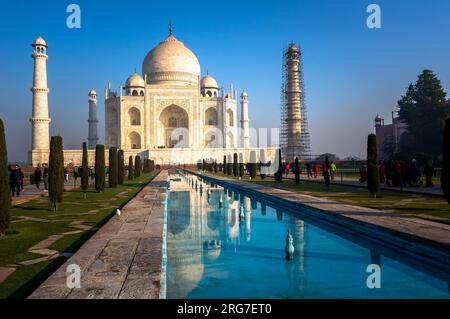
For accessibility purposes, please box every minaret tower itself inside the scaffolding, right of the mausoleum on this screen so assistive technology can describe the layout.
[284,43,302,161]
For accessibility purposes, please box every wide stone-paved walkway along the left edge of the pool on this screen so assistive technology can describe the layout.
[29,171,168,299]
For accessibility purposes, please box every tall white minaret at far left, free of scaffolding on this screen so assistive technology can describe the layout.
[30,36,50,152]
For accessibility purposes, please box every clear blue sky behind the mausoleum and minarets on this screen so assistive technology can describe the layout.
[0,0,450,161]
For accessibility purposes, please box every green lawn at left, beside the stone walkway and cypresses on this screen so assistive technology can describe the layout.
[0,171,158,299]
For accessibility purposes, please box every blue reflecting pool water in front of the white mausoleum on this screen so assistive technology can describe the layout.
[166,175,450,298]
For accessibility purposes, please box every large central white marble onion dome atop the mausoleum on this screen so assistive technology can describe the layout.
[142,35,200,84]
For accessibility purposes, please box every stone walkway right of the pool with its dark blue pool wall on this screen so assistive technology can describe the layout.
[196,171,450,269]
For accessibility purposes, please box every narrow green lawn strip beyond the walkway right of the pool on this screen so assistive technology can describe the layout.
[205,173,450,224]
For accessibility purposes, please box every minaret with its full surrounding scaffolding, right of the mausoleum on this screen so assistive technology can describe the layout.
[280,43,311,162]
